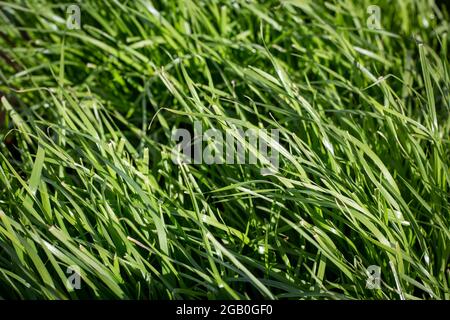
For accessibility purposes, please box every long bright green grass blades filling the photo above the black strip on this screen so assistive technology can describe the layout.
[0,0,450,299]
